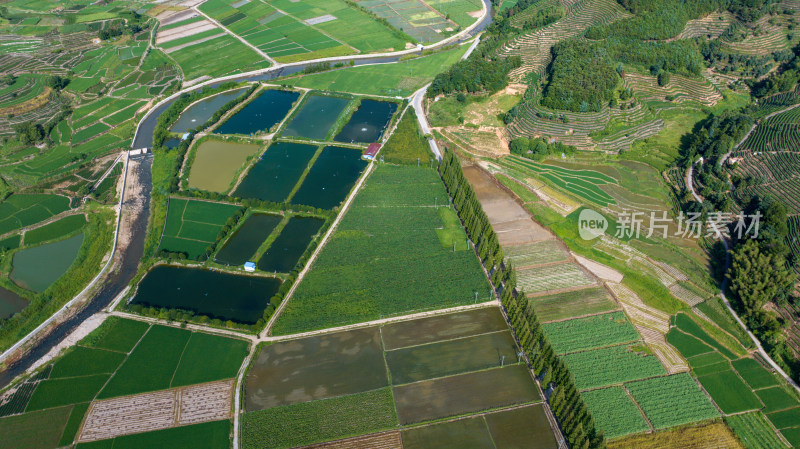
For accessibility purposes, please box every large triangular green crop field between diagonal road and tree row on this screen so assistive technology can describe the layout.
[272,165,489,335]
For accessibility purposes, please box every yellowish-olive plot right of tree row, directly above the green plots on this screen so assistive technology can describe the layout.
[528,287,619,322]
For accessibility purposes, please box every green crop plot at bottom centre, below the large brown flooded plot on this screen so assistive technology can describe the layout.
[242,388,397,449]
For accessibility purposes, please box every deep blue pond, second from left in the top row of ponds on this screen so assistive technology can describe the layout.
[214,90,300,135]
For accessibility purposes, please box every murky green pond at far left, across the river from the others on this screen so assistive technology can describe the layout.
[11,234,83,292]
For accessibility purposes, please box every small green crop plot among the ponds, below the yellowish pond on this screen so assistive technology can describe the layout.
[159,198,241,259]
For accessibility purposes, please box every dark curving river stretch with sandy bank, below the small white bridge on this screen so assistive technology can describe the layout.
[0,154,153,388]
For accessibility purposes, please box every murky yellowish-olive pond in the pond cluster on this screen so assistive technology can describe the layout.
[189,140,259,192]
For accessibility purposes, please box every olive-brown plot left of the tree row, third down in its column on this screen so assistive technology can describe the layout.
[394,365,541,425]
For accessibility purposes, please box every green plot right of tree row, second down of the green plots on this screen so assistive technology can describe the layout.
[564,345,666,390]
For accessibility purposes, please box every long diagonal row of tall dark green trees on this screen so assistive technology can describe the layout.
[439,150,606,449]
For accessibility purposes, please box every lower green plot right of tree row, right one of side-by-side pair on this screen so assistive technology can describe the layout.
[625,373,719,429]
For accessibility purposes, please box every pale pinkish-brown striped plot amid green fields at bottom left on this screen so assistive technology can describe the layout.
[77,379,234,442]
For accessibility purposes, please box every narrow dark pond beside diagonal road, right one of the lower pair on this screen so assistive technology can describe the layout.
[257,217,324,273]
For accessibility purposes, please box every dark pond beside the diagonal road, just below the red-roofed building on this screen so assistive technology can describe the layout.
[291,147,367,209]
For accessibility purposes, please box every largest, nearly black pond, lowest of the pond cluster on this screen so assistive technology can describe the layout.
[132,265,281,324]
